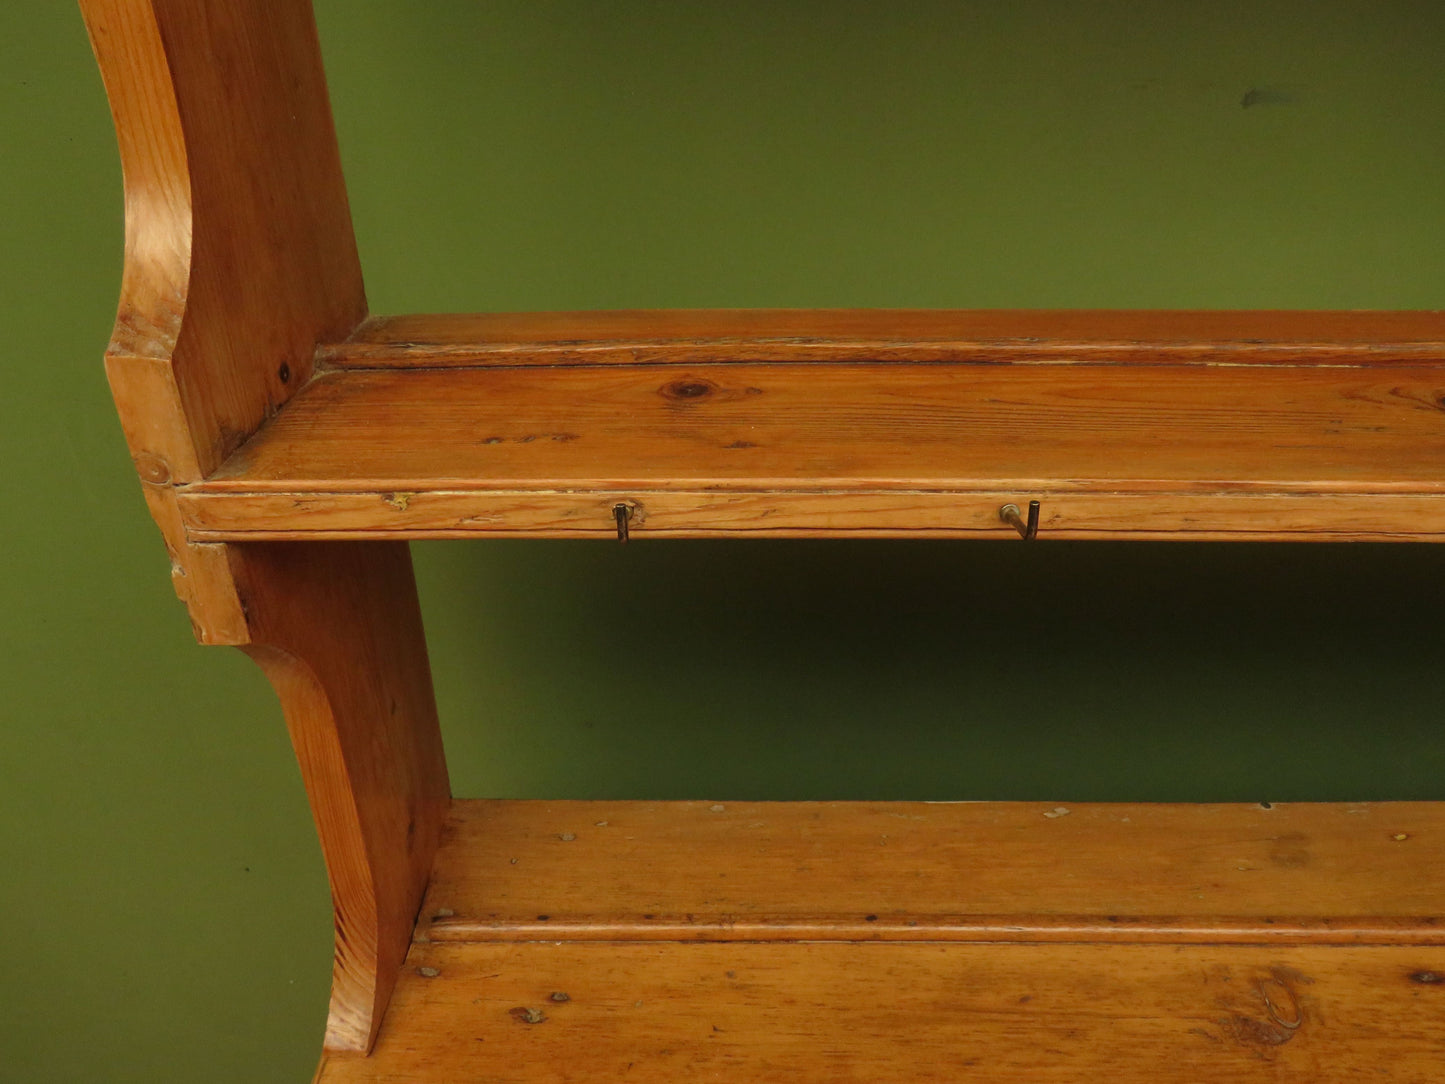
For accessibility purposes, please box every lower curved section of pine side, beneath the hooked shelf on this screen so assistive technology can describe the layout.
[228,542,449,1051]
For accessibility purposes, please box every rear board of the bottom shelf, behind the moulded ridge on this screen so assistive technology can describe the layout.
[418,801,1445,944]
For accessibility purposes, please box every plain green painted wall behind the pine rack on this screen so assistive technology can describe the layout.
[0,0,1445,1084]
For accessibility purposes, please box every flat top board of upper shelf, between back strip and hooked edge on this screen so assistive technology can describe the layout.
[197,363,1445,491]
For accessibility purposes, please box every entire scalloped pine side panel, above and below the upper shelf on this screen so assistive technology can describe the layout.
[81,0,413,1048]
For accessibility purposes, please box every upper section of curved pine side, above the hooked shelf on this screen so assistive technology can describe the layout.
[81,0,366,481]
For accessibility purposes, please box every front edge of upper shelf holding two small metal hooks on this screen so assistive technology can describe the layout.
[178,483,1445,542]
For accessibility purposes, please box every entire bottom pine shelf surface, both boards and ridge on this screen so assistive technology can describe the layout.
[318,802,1445,1084]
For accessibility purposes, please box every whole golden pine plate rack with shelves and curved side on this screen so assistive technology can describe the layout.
[81,0,1445,1084]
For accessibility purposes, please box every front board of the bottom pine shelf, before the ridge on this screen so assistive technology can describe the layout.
[318,942,1445,1084]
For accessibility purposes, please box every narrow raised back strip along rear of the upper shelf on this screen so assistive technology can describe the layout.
[322,309,1445,367]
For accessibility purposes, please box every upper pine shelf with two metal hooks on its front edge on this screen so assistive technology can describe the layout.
[181,314,1445,541]
